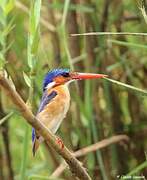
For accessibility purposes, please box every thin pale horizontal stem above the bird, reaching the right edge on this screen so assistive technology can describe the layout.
[71,32,147,36]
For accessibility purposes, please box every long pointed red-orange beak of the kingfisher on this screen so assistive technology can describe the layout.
[71,72,107,80]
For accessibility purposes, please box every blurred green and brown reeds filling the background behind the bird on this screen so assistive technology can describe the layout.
[0,0,147,180]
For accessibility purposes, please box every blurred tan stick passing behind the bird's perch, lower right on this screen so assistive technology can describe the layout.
[51,135,129,177]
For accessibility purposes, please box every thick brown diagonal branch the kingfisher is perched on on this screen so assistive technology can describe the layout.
[0,72,91,180]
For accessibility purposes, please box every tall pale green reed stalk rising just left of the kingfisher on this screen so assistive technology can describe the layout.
[20,0,41,179]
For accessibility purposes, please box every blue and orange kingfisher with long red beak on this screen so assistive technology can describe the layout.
[32,69,107,155]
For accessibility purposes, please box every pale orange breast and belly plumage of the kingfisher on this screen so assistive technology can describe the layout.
[37,85,70,133]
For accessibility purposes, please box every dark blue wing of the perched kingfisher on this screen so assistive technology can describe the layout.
[32,91,57,142]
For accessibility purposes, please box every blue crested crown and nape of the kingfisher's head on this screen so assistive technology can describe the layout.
[43,69,70,91]
